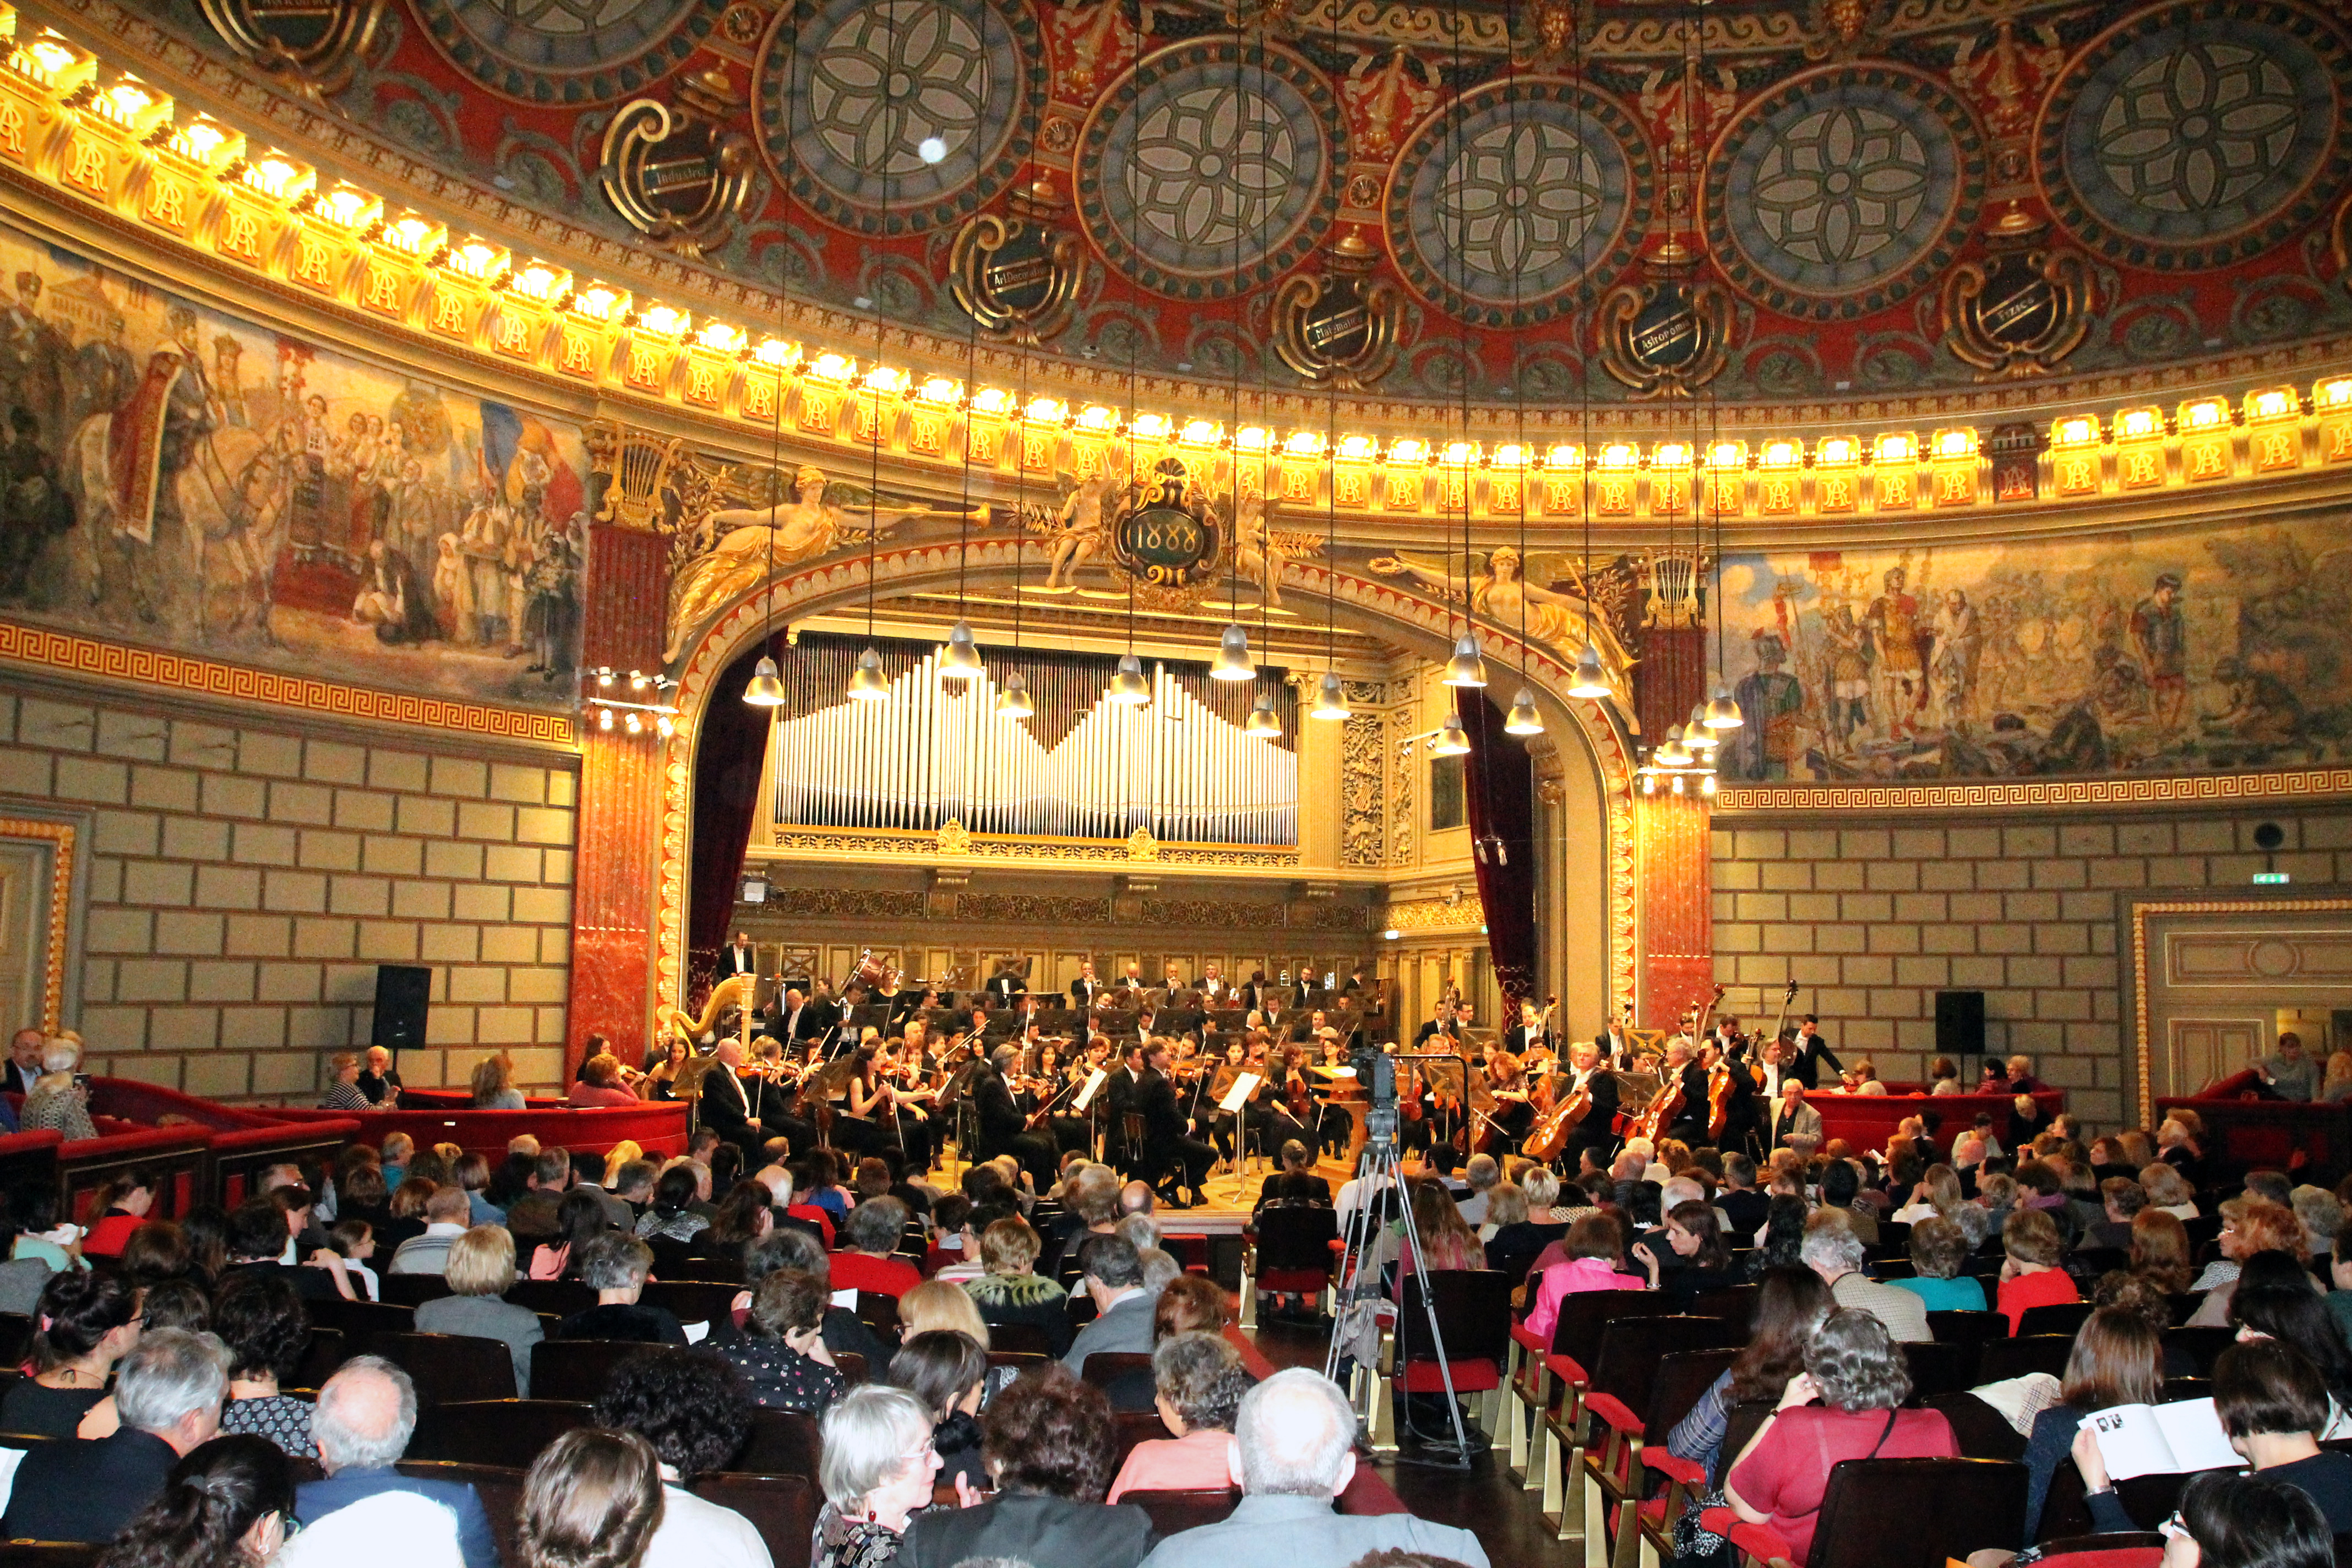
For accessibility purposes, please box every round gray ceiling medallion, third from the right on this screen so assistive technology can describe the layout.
[1385,78,1651,327]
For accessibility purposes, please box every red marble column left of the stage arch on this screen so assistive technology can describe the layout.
[564,524,671,1081]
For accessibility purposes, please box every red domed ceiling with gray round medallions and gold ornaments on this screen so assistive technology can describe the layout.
[156,0,2352,407]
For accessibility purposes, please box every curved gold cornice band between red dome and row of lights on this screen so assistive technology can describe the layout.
[19,0,2352,444]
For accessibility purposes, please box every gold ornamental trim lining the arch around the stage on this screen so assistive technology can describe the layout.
[654,541,1635,1025]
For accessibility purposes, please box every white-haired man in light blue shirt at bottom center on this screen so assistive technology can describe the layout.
[1143,1366,1487,1568]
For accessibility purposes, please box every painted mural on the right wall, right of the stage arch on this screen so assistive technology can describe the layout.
[1724,522,2352,781]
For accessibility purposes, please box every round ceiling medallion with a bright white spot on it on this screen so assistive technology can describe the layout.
[753,0,1047,235]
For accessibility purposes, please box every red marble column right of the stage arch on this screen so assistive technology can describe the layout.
[1632,628,1714,1030]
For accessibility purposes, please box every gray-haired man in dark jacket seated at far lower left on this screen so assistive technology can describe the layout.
[0,1328,228,1542]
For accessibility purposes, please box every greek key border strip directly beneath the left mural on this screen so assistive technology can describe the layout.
[0,620,579,745]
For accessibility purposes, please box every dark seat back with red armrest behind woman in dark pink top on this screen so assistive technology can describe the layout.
[1705,1460,2025,1568]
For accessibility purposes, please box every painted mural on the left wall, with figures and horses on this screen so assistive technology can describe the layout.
[0,226,588,705]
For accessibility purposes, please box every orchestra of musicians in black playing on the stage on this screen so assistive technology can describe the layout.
[654,940,1827,1204]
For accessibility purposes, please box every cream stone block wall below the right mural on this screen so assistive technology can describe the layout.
[1712,804,2352,1129]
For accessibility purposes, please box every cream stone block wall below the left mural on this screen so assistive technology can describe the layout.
[0,696,579,1103]
